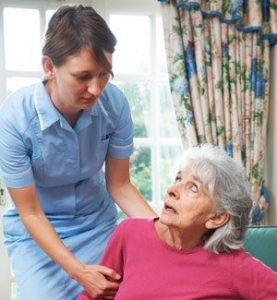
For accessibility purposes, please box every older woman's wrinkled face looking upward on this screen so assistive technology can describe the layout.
[160,169,215,231]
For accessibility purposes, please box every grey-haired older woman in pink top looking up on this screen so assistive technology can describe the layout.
[78,145,277,300]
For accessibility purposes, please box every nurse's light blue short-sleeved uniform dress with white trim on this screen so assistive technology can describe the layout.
[0,82,133,300]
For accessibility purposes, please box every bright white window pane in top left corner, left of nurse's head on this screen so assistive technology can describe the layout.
[4,8,41,71]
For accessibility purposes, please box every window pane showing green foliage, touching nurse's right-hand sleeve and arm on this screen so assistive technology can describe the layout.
[131,147,152,201]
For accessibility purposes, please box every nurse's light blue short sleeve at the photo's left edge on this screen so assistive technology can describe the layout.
[0,99,34,188]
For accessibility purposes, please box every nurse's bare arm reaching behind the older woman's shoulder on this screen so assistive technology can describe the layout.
[106,156,157,217]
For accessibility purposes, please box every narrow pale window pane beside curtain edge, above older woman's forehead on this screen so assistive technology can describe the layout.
[158,83,180,137]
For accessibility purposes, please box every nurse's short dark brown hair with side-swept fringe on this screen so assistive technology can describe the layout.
[42,5,116,70]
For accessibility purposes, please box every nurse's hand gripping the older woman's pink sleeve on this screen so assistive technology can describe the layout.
[74,265,121,300]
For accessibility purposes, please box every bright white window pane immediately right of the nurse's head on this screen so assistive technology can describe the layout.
[110,15,150,74]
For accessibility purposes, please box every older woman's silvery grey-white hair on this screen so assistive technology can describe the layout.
[178,144,253,253]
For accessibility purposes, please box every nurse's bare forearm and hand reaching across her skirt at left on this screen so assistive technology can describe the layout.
[9,185,119,296]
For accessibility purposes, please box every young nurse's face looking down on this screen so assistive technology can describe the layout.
[47,49,112,114]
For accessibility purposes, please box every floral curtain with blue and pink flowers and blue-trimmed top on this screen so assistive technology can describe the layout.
[157,0,277,223]
